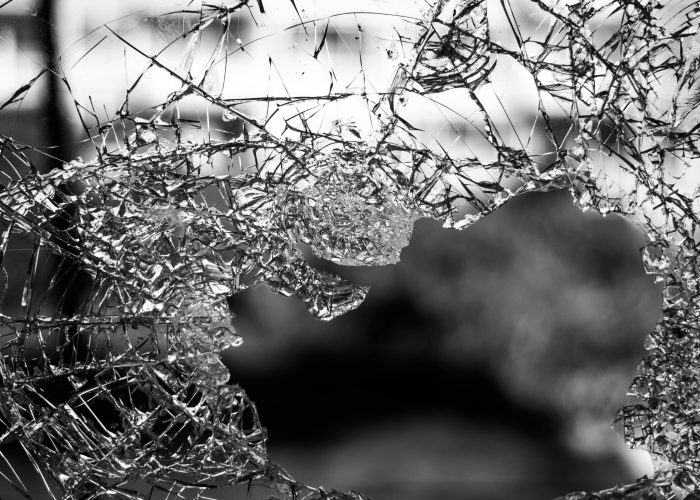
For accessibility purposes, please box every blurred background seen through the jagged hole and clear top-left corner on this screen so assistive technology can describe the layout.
[0,0,661,500]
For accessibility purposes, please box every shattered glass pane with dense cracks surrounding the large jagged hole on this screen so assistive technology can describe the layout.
[0,0,700,500]
